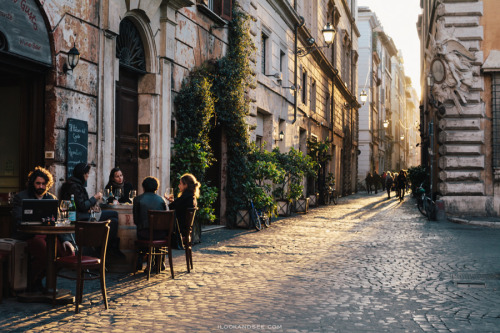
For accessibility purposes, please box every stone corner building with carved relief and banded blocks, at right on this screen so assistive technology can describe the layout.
[417,0,500,216]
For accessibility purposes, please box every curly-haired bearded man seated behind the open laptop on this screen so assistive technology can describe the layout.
[12,167,75,290]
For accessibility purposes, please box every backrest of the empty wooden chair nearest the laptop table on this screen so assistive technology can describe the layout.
[75,220,111,259]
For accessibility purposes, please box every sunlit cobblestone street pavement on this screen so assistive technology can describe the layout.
[0,193,500,332]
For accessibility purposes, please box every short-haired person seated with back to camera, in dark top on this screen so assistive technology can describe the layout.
[133,177,167,240]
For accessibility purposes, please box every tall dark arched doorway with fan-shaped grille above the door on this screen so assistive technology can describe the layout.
[115,18,146,188]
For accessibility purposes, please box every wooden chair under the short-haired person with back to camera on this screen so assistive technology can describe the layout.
[135,210,175,280]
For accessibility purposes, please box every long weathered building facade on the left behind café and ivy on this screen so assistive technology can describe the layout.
[0,0,359,224]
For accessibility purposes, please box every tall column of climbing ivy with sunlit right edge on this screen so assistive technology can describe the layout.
[213,6,255,221]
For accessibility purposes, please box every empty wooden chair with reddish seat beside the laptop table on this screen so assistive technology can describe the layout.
[52,220,111,313]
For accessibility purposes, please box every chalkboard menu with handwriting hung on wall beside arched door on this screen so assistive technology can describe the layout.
[66,118,89,178]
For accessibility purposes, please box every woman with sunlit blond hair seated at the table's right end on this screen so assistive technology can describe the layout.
[166,173,200,237]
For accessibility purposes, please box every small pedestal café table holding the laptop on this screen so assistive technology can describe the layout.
[17,225,75,303]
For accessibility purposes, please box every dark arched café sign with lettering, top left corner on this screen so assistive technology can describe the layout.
[0,0,52,66]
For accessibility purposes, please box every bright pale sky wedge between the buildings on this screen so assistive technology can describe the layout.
[358,0,421,97]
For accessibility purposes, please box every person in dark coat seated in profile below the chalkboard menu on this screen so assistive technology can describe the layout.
[61,163,125,259]
